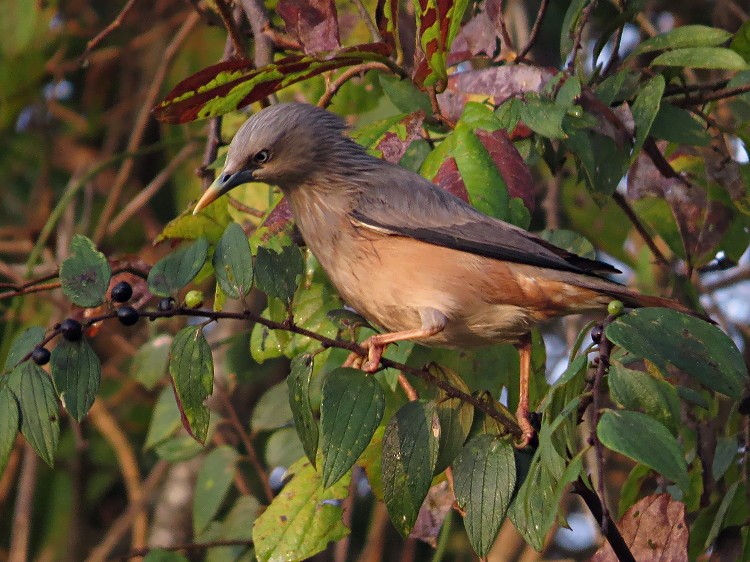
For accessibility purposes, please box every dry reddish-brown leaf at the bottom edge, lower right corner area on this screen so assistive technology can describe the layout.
[589,494,688,562]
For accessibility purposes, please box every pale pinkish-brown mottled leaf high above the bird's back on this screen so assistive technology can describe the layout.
[438,64,554,121]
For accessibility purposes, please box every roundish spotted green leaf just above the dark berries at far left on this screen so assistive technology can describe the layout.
[60,234,112,308]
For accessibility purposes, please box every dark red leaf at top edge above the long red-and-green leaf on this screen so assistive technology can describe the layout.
[276,0,341,54]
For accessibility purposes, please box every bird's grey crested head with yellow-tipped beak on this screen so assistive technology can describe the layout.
[194,103,372,212]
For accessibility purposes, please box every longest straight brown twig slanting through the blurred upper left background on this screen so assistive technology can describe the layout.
[93,12,200,244]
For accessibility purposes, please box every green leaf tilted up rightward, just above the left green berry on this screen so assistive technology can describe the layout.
[148,237,208,297]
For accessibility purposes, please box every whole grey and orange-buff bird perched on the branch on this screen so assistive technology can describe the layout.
[194,103,684,448]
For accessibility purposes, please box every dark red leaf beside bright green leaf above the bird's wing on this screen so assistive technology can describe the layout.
[476,129,534,212]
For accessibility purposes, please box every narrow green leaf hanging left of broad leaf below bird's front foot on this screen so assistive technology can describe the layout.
[286,354,318,467]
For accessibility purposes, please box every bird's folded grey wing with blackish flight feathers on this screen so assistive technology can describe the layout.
[350,162,619,276]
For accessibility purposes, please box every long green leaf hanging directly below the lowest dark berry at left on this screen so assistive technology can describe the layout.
[8,361,60,467]
